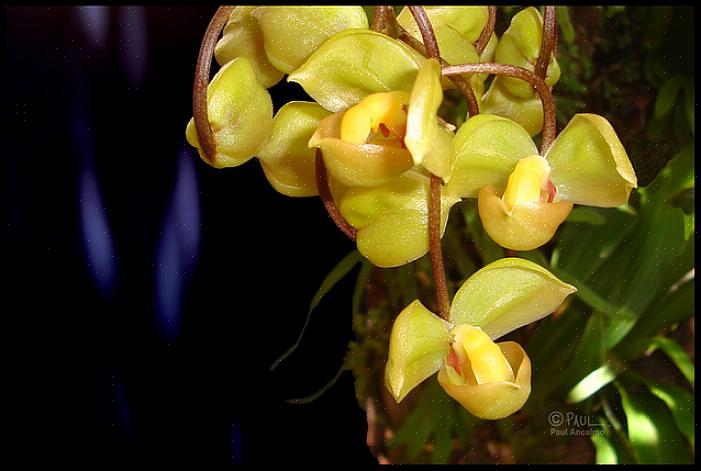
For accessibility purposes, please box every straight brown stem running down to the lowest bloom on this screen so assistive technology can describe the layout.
[428,175,450,320]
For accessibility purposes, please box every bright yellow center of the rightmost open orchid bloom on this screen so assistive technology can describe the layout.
[501,155,552,214]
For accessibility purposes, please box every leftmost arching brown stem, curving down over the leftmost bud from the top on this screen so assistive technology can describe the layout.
[192,6,235,163]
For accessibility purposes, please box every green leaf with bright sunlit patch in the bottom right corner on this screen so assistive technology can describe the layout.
[616,383,691,464]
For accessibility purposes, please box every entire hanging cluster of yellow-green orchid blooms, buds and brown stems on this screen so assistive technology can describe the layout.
[186,6,637,419]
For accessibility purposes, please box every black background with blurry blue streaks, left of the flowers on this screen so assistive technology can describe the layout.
[1,6,374,464]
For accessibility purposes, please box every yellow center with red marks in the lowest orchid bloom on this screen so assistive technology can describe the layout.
[447,325,514,384]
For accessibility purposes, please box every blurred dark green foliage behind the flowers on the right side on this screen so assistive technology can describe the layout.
[302,6,695,463]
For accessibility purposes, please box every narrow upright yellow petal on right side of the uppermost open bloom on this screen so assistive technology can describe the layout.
[404,59,454,181]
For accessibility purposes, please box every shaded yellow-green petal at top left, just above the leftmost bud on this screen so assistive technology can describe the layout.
[214,6,285,88]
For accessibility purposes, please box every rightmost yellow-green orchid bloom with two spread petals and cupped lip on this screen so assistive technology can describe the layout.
[445,114,637,250]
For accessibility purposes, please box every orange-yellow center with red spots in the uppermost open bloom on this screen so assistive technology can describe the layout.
[341,91,410,144]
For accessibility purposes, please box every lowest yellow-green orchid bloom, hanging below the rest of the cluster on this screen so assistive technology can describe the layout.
[385,258,576,420]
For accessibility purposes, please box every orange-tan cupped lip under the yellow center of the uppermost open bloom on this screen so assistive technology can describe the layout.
[309,112,414,186]
